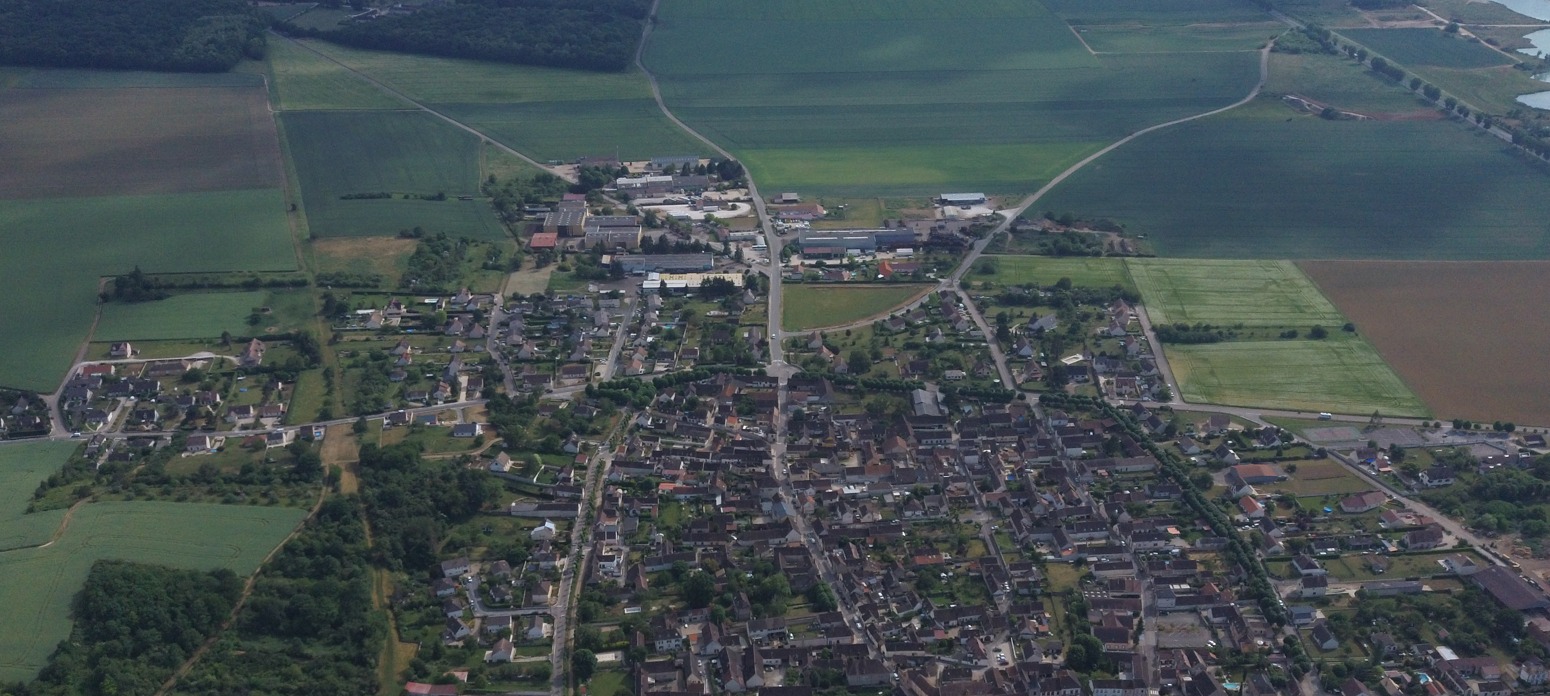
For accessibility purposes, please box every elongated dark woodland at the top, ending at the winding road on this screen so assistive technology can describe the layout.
[279,0,651,70]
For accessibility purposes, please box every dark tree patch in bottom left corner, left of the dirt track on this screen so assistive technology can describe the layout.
[14,561,242,696]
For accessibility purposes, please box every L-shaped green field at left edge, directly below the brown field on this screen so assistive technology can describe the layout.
[0,189,296,392]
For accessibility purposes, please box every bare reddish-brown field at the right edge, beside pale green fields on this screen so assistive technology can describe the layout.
[1297,260,1550,426]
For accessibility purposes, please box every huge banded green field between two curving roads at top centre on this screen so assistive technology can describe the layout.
[643,0,1271,197]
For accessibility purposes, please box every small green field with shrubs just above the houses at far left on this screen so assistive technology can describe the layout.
[91,290,313,341]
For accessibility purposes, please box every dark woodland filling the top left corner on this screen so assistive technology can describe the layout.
[0,0,265,73]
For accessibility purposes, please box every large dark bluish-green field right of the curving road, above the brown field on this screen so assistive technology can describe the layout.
[1039,96,1550,259]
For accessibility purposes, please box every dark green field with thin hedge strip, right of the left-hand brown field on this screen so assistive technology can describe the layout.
[281,112,505,239]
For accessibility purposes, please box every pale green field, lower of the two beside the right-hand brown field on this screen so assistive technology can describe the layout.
[1166,339,1429,417]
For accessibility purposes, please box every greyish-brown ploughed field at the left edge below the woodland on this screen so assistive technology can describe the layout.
[0,87,281,198]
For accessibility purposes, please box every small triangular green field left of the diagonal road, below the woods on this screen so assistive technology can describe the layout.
[268,37,412,110]
